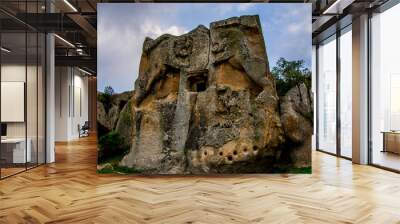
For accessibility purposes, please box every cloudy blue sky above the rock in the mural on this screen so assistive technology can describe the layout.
[97,3,312,93]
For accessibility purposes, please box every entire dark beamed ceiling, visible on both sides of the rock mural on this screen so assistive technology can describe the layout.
[0,0,394,74]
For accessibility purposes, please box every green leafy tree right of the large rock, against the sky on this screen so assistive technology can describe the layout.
[271,58,311,96]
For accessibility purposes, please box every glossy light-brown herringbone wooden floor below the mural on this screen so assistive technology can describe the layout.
[0,138,400,224]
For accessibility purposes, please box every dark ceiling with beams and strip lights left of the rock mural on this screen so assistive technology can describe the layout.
[0,0,100,74]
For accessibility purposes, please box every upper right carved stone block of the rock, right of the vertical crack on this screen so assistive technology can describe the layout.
[210,16,272,88]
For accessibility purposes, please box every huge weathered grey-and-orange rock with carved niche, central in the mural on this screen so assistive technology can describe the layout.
[120,16,307,174]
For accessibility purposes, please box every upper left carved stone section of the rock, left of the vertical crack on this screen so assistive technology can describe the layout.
[134,26,210,106]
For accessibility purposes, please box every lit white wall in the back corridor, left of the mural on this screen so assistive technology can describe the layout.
[55,67,89,141]
